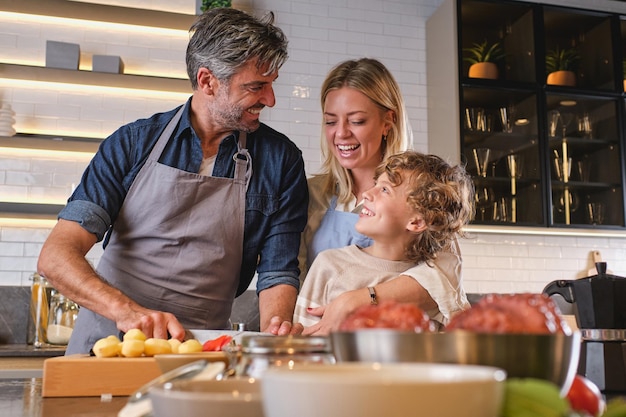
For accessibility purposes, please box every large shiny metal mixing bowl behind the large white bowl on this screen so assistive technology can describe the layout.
[330,329,580,393]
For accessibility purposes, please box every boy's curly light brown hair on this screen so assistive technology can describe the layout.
[376,151,474,263]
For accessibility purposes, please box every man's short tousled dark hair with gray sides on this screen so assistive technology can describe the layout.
[186,8,288,90]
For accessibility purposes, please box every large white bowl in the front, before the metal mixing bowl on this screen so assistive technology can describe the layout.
[261,363,506,417]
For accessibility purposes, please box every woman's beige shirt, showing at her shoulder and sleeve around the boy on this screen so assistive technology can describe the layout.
[296,172,470,326]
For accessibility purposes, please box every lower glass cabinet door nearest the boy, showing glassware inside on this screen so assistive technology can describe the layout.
[462,87,545,225]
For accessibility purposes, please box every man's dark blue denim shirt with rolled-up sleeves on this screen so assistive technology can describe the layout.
[59,98,309,295]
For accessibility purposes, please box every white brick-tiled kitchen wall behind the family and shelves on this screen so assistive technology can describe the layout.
[0,0,626,293]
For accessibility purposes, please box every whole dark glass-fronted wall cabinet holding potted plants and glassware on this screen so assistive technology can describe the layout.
[427,0,626,229]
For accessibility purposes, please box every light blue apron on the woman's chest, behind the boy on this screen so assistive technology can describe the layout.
[307,196,372,268]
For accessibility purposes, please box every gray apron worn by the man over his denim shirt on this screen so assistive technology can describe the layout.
[66,107,252,354]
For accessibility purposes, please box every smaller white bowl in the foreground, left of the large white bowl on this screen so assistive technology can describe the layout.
[150,378,263,417]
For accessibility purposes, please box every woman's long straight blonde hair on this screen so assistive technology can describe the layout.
[319,58,413,203]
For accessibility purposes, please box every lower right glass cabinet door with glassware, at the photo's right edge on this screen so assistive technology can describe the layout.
[546,94,624,226]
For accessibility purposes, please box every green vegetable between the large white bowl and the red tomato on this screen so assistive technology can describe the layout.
[502,378,570,417]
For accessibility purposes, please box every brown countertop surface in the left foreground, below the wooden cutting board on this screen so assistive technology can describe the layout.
[0,378,128,417]
